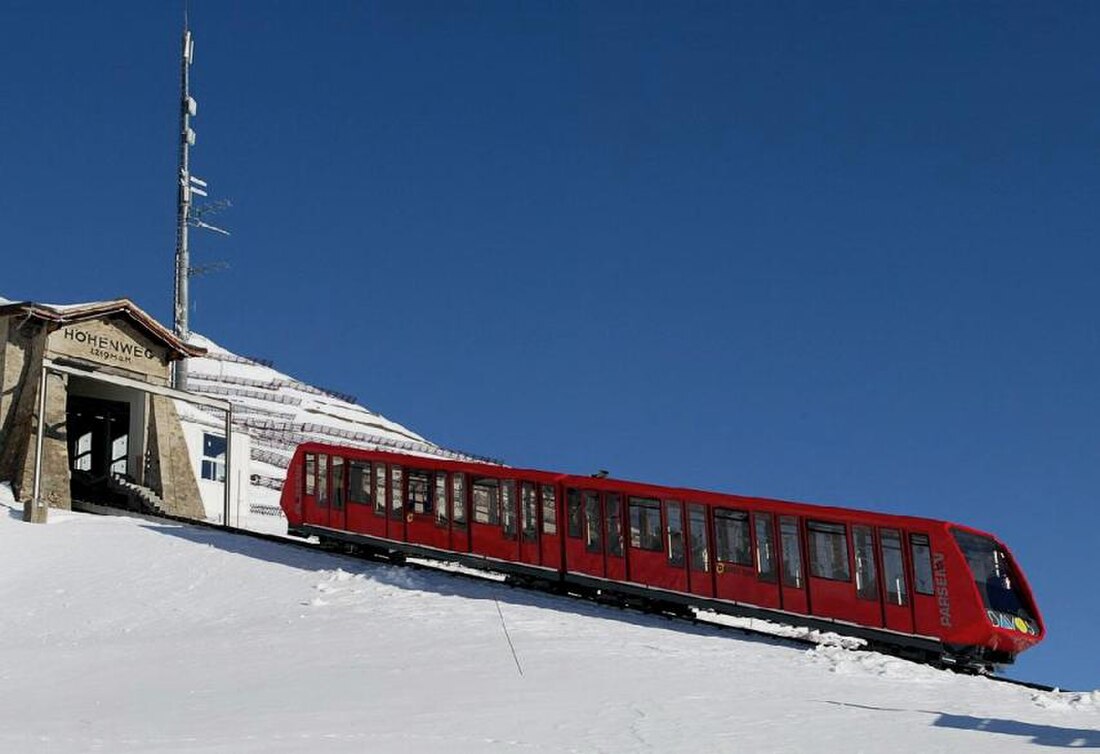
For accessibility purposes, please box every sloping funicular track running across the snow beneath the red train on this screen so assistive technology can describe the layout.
[73,501,1065,691]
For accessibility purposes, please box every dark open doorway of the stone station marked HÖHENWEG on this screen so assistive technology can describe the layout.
[65,395,130,505]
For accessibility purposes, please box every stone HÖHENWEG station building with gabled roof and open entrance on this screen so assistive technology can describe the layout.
[0,298,228,521]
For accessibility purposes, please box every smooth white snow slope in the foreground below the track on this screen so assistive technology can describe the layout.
[0,487,1100,754]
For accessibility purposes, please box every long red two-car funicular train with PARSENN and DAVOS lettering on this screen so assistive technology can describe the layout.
[281,442,1045,669]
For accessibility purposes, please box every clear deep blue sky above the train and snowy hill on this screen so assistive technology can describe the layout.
[0,0,1100,689]
